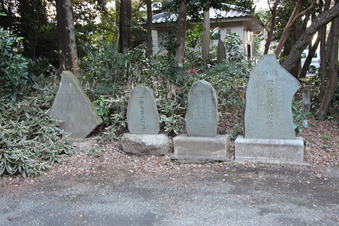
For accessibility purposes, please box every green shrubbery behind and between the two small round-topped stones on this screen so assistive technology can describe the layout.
[81,35,255,141]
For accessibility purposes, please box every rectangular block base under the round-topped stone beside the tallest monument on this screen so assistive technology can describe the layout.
[171,135,230,163]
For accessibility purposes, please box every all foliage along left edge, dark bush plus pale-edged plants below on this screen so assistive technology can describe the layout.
[0,29,73,177]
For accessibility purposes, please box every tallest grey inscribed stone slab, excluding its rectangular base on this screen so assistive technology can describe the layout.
[244,54,300,139]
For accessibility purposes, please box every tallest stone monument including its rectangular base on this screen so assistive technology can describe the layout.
[235,54,304,164]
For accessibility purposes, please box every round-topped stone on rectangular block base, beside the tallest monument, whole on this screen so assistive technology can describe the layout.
[171,80,230,162]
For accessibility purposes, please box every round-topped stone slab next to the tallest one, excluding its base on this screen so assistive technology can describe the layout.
[185,80,219,137]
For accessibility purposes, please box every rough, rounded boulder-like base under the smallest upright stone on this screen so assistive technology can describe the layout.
[121,133,171,155]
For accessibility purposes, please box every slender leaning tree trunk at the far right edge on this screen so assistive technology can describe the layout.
[317,0,339,120]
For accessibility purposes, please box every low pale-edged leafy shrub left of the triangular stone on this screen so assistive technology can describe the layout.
[0,77,73,177]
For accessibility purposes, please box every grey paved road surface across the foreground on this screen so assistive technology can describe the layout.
[0,163,339,225]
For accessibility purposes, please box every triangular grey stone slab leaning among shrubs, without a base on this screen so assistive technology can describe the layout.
[49,71,102,138]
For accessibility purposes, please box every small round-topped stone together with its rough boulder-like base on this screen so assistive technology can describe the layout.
[121,85,170,155]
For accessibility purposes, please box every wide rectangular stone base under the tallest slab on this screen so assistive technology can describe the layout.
[235,136,307,165]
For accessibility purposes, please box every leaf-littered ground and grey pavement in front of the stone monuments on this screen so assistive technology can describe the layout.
[0,117,339,225]
